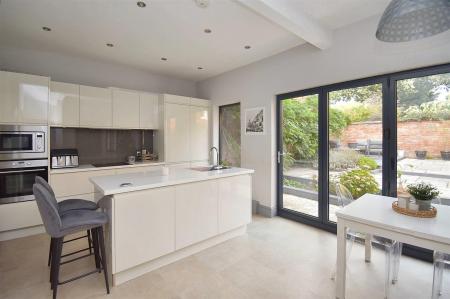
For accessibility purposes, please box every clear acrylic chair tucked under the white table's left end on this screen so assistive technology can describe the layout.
[332,183,403,298]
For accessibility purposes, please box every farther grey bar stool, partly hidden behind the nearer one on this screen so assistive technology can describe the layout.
[35,176,98,266]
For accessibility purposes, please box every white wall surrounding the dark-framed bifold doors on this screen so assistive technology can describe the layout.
[197,17,450,213]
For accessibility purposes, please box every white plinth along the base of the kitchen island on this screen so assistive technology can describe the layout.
[112,225,247,286]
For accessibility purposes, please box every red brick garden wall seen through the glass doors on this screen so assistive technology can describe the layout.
[340,120,450,158]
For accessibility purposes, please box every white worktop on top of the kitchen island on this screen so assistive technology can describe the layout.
[89,167,255,195]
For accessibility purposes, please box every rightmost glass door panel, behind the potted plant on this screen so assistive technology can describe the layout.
[396,73,450,205]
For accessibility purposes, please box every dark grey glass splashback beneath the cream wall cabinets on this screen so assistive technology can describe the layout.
[50,128,154,164]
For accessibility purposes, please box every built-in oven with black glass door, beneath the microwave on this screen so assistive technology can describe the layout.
[0,166,48,204]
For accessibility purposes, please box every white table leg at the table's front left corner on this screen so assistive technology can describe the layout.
[336,219,347,299]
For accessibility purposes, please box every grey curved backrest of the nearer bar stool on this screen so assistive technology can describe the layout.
[33,184,62,237]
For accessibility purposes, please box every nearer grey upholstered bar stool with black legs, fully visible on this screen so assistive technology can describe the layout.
[33,184,109,299]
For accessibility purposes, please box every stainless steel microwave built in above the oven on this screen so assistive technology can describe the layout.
[0,125,48,161]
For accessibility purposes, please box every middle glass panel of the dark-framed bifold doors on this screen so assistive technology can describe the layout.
[328,83,383,222]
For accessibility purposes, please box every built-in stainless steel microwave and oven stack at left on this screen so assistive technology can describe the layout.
[0,125,48,204]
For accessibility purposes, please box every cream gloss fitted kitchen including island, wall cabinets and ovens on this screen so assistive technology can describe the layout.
[0,71,253,296]
